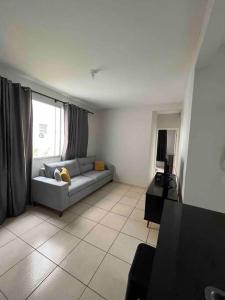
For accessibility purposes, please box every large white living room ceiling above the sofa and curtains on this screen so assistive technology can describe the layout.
[0,0,207,108]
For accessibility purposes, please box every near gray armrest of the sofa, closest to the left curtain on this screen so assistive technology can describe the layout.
[31,176,69,211]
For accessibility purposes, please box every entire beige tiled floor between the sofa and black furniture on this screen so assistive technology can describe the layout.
[0,182,159,300]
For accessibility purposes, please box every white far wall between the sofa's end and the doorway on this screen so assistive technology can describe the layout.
[97,107,152,187]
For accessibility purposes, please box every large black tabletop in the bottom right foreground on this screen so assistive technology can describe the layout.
[148,201,225,300]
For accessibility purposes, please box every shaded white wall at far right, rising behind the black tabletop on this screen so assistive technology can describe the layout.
[184,46,225,212]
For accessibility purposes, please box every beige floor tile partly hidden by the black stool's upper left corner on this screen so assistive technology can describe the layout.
[109,233,142,264]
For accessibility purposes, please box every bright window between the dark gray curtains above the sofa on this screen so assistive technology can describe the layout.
[33,99,63,158]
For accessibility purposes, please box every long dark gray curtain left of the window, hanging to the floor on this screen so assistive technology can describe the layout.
[0,77,32,223]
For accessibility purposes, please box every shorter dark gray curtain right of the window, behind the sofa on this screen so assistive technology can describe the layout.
[63,104,88,159]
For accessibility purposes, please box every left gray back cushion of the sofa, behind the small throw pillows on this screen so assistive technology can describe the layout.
[44,159,80,178]
